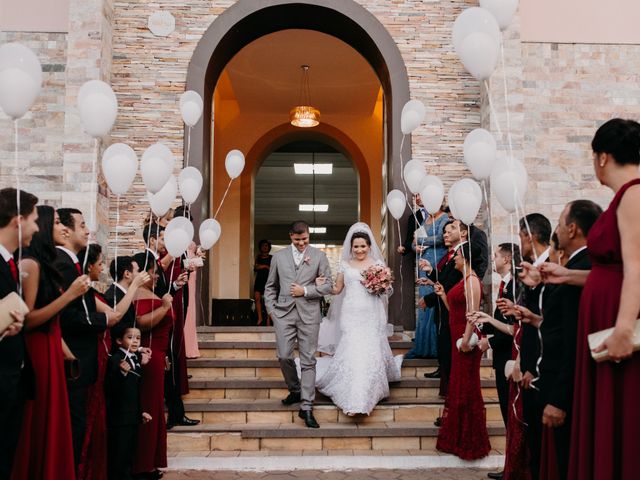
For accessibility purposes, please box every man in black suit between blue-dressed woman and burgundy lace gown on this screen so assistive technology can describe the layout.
[418,220,469,396]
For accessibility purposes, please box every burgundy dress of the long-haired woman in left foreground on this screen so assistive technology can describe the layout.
[11,276,76,480]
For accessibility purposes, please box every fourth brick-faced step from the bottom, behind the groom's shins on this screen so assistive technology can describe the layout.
[188,358,494,380]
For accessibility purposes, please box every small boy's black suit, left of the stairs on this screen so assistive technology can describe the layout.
[106,349,142,480]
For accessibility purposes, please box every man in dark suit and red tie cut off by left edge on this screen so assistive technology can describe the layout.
[0,188,38,479]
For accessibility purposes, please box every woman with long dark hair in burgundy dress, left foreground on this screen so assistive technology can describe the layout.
[12,205,89,480]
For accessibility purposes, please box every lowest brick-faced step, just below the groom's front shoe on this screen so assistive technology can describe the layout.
[168,422,505,455]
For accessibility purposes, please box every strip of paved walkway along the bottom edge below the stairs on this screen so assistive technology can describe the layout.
[163,468,491,480]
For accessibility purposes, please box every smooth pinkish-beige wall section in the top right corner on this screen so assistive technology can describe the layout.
[520,0,640,44]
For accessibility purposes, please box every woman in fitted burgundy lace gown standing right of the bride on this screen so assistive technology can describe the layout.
[434,243,491,460]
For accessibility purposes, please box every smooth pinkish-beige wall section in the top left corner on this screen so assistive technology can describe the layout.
[0,0,69,32]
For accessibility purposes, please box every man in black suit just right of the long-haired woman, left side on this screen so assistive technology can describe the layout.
[54,208,115,466]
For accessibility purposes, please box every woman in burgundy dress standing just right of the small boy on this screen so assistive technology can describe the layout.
[133,252,173,479]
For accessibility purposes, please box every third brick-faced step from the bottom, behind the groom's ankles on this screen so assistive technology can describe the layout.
[184,377,496,400]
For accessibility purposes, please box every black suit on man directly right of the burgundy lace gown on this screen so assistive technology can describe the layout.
[483,277,518,426]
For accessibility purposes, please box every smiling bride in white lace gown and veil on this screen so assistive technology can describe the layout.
[316,222,402,415]
